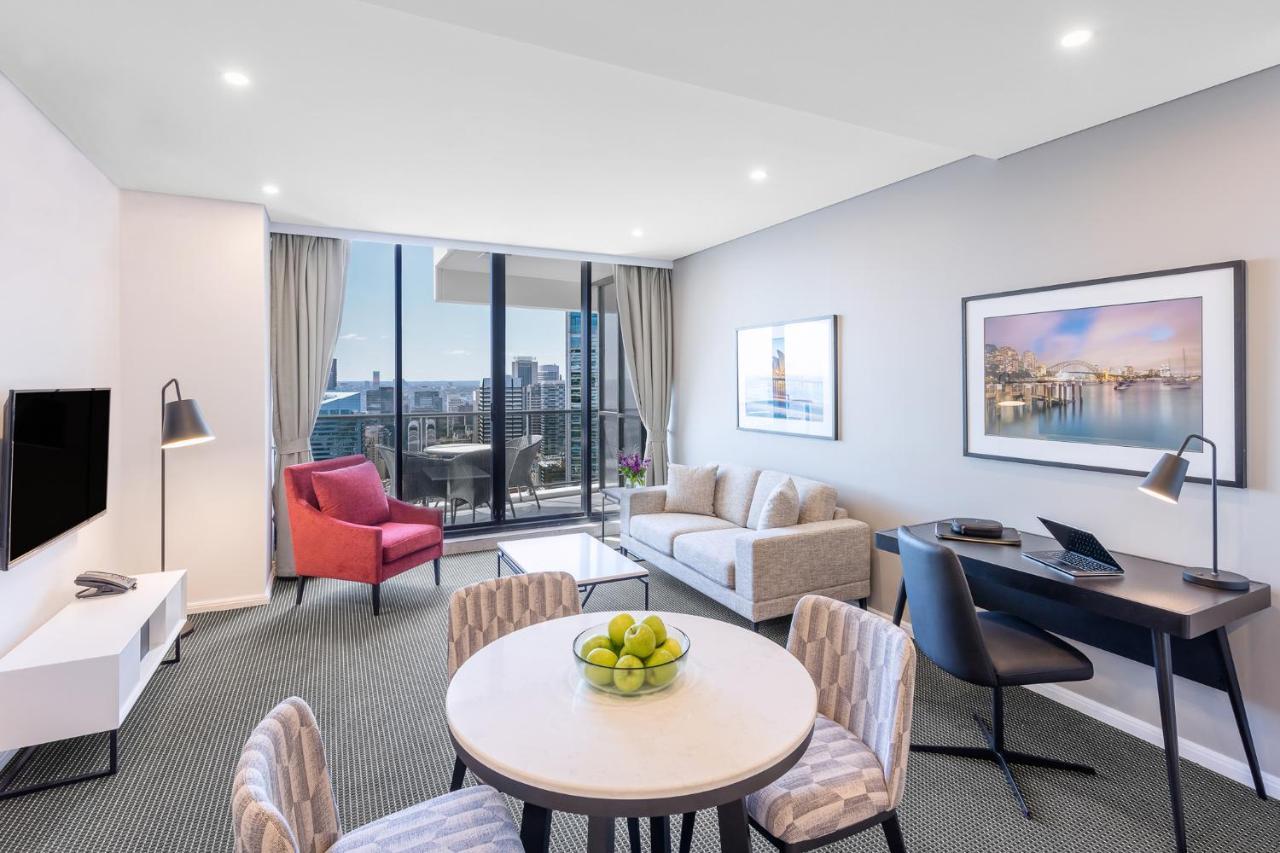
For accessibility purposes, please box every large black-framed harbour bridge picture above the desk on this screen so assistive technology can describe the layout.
[961,261,1245,488]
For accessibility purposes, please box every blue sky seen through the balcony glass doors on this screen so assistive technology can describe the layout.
[334,242,564,382]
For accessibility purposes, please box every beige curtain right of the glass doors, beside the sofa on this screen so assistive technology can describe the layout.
[614,264,675,485]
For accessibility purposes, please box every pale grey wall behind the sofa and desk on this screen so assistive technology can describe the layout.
[673,69,1280,774]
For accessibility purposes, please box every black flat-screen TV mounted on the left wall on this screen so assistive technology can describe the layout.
[0,388,111,569]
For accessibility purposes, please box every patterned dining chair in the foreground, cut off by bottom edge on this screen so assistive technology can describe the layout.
[232,697,524,853]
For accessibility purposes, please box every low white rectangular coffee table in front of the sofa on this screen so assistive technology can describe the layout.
[498,533,649,610]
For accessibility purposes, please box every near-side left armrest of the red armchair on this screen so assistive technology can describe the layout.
[289,501,383,584]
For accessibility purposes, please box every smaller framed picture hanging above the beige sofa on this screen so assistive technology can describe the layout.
[735,314,840,441]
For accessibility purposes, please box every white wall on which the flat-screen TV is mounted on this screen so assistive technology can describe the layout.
[0,76,124,654]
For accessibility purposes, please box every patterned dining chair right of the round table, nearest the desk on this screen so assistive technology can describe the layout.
[746,596,915,853]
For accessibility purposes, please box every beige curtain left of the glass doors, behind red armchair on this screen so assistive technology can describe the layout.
[271,234,351,578]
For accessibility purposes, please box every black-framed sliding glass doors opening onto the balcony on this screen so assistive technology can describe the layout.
[311,242,611,529]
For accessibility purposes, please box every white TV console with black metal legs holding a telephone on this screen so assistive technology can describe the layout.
[0,571,187,799]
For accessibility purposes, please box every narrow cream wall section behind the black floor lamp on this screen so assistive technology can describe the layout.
[120,192,271,608]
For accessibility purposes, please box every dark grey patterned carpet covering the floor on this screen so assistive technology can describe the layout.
[0,552,1280,853]
